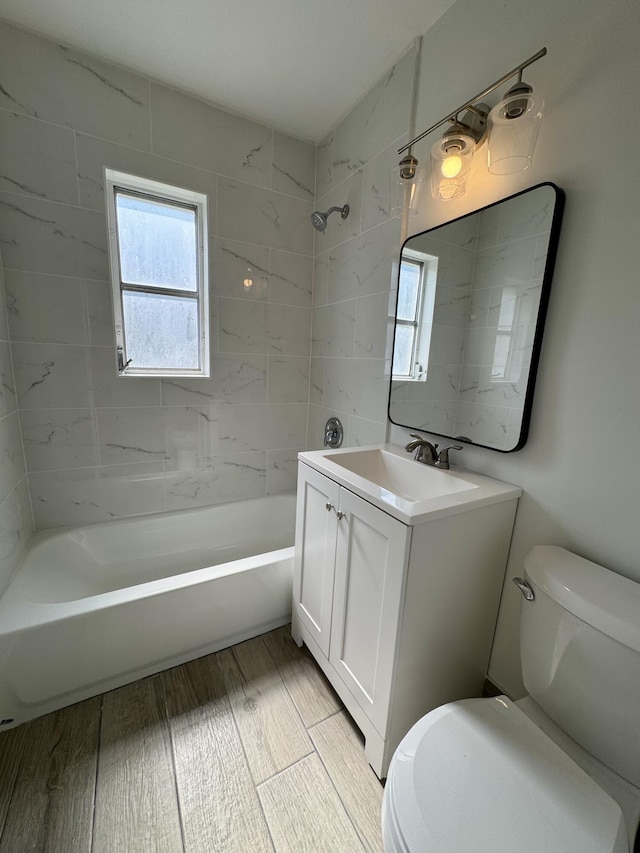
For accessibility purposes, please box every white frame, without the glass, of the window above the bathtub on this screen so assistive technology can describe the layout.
[104,168,211,377]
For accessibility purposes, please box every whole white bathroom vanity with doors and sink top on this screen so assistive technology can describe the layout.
[292,445,521,778]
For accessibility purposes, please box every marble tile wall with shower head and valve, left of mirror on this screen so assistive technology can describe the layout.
[308,48,415,448]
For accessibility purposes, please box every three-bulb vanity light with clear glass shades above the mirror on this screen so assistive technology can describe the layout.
[398,47,547,201]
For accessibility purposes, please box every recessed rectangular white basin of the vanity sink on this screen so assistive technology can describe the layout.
[325,447,478,501]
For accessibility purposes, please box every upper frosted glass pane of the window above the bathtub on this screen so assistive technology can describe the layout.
[116,192,198,291]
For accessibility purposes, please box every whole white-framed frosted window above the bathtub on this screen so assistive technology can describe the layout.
[105,169,210,376]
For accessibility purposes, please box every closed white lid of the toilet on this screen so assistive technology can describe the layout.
[385,696,629,853]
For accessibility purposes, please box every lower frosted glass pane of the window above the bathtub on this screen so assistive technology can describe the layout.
[122,290,200,370]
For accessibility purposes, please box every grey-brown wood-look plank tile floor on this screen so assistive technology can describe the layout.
[0,627,383,853]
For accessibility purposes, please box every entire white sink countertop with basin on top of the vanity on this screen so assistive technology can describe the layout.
[298,444,521,524]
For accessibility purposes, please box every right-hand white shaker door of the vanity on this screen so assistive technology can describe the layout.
[330,489,411,736]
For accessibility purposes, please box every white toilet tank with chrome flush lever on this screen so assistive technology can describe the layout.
[520,545,640,787]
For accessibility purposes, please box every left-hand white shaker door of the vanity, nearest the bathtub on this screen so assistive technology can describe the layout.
[293,463,340,658]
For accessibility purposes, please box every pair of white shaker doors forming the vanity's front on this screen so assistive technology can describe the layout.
[293,465,410,729]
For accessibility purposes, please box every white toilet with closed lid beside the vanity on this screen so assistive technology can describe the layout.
[382,546,640,853]
